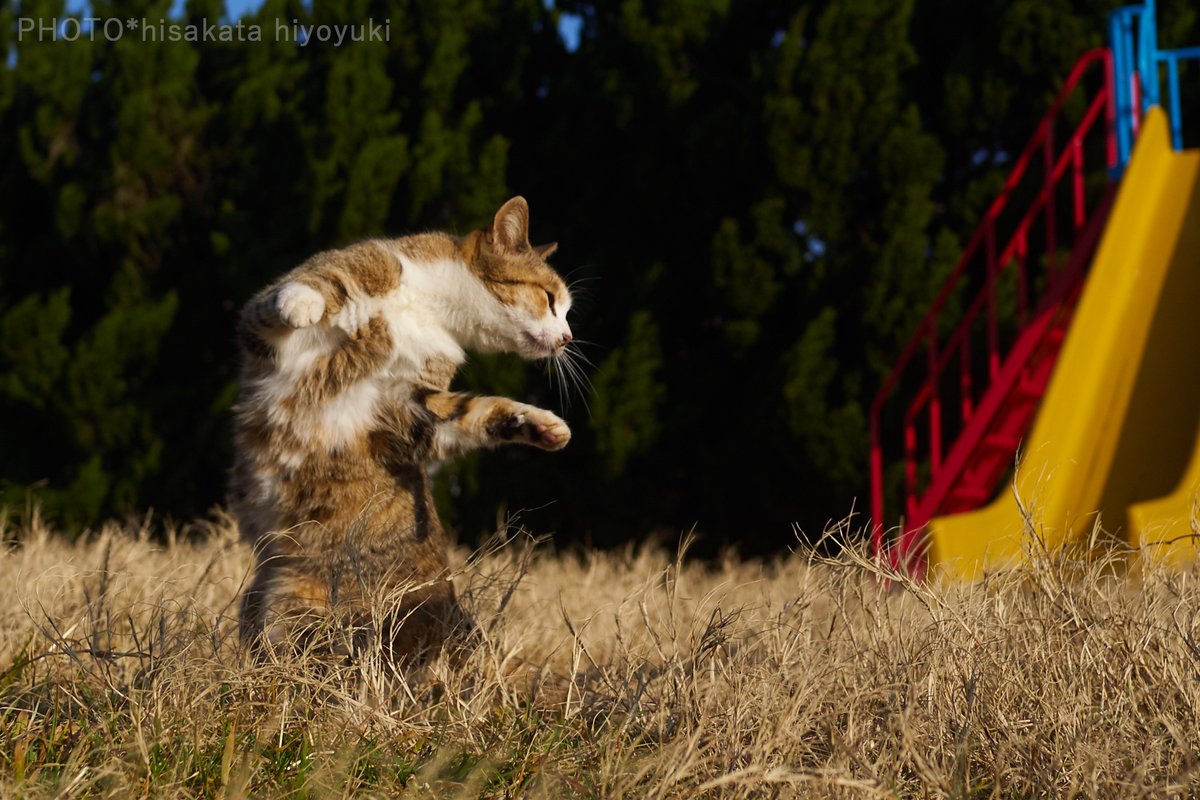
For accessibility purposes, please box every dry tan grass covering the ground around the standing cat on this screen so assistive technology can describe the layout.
[0,510,1200,798]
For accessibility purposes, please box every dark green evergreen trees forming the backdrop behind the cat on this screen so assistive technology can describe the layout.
[0,0,1200,547]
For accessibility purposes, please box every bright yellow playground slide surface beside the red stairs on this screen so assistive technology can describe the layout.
[929,108,1200,579]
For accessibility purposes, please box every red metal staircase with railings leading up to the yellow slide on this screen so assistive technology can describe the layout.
[870,49,1116,572]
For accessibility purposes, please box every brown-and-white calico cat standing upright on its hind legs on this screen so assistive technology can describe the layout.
[230,197,571,656]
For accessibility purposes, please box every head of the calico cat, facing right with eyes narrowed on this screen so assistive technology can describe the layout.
[468,197,572,359]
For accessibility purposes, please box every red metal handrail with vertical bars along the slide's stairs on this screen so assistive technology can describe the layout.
[870,48,1116,563]
